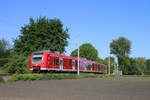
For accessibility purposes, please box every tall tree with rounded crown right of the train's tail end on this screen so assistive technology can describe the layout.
[110,37,131,74]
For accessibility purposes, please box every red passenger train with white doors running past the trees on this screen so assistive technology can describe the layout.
[30,51,107,73]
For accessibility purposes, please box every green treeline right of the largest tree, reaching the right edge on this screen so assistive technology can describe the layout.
[71,41,150,75]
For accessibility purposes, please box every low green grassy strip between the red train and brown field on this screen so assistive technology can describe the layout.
[8,73,110,82]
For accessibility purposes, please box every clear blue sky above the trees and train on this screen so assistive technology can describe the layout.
[0,0,150,58]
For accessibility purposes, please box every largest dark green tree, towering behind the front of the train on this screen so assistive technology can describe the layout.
[14,17,69,55]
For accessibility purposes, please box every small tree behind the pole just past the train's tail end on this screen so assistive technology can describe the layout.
[104,56,116,73]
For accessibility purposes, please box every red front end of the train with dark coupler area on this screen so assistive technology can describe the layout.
[30,52,47,72]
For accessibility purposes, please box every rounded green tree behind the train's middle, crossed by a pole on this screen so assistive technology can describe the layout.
[71,43,98,61]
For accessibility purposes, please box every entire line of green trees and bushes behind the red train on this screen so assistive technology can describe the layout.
[0,17,150,75]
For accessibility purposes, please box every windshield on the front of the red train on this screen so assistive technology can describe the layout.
[32,53,43,64]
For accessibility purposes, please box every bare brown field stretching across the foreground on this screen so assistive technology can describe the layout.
[0,77,150,100]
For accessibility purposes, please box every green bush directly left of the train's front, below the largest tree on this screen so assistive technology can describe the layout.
[4,55,29,74]
